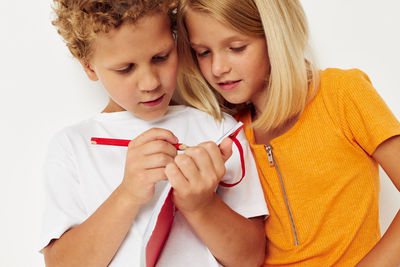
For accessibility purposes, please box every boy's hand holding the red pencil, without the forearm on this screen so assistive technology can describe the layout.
[120,128,178,205]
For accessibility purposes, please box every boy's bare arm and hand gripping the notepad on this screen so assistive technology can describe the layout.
[166,139,266,266]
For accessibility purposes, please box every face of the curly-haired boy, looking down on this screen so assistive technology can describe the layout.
[82,14,178,120]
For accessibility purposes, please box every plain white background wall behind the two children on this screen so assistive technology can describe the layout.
[0,0,400,267]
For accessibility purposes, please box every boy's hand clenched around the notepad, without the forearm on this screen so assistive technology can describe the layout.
[165,138,232,213]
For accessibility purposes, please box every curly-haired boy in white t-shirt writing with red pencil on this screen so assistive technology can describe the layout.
[41,0,267,266]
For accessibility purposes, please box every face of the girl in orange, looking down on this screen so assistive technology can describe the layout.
[185,9,270,106]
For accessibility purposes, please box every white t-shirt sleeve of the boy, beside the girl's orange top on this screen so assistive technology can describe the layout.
[217,116,268,218]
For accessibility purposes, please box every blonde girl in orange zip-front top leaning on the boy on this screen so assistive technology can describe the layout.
[178,0,400,266]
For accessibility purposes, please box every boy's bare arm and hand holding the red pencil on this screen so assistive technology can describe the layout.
[43,129,177,267]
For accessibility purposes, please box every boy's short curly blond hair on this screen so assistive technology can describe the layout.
[52,0,177,61]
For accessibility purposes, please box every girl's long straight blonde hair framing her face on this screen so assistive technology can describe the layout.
[177,0,319,130]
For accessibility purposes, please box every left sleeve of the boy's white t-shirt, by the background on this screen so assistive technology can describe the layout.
[39,133,86,250]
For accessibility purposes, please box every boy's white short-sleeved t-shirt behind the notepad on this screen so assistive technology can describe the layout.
[40,106,268,267]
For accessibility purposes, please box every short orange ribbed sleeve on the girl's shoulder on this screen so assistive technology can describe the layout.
[338,69,400,155]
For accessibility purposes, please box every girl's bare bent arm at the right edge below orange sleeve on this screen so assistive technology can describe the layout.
[357,136,400,267]
